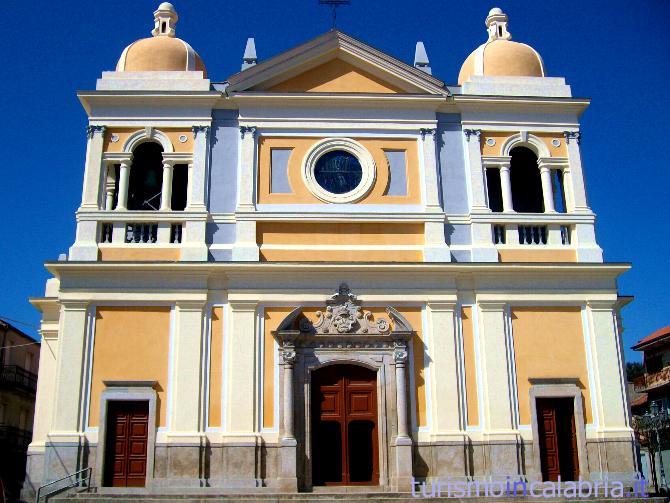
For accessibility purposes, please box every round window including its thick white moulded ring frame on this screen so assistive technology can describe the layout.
[303,138,376,203]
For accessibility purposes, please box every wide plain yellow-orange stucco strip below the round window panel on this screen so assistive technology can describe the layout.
[256,222,424,262]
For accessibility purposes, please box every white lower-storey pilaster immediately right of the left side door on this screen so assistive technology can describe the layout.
[168,301,205,438]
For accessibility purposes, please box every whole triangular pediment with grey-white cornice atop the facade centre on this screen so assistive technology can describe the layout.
[228,30,449,95]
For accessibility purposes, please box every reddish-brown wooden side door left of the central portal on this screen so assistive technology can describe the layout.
[104,401,149,487]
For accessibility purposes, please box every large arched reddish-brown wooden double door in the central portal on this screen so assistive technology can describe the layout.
[312,365,379,486]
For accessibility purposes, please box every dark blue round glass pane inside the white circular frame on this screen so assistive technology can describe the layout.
[314,150,363,194]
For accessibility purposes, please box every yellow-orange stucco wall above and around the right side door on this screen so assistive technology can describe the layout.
[512,307,593,425]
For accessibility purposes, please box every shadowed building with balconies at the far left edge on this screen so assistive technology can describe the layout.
[0,320,40,500]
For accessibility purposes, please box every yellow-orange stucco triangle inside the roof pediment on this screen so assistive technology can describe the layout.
[266,59,404,94]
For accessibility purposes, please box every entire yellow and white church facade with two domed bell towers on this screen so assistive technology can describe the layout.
[24,3,637,500]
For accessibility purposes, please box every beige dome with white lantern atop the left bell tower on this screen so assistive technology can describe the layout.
[116,2,207,77]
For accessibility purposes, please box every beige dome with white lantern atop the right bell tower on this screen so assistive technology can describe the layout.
[458,9,545,85]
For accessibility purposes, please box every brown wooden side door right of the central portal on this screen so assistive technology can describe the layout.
[536,398,579,481]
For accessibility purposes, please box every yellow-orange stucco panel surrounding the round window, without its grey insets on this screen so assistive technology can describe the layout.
[258,137,421,204]
